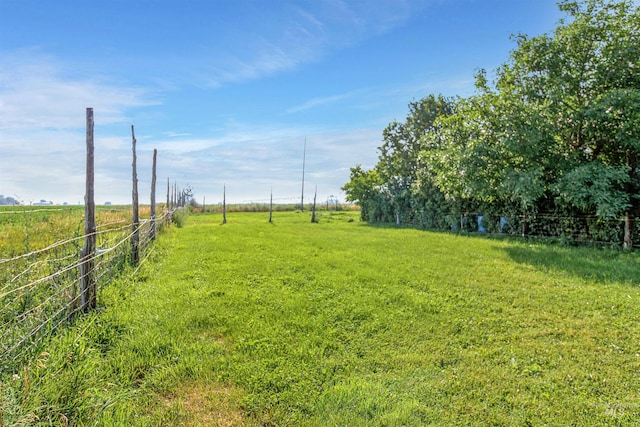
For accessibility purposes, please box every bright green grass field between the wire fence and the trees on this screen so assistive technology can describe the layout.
[0,212,640,426]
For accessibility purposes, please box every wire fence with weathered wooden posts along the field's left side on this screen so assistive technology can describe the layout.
[0,108,190,371]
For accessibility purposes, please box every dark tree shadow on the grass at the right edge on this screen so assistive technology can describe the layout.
[502,244,640,286]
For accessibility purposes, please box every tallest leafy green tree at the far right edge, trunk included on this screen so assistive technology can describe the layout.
[499,0,640,247]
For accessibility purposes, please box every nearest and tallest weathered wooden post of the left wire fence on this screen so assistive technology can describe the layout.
[78,108,97,311]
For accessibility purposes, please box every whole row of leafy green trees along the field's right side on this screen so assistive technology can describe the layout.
[342,0,640,248]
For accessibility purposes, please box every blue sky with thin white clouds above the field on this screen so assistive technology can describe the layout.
[0,0,562,204]
